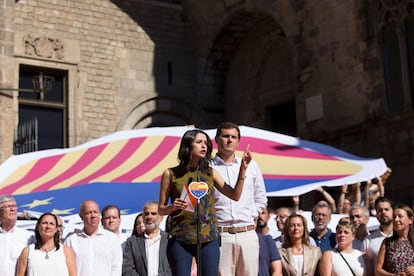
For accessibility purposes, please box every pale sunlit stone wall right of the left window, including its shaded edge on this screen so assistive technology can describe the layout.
[9,0,193,150]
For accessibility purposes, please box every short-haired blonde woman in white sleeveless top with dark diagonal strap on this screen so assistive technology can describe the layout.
[319,220,373,276]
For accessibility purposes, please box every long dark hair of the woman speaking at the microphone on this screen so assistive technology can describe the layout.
[178,129,213,173]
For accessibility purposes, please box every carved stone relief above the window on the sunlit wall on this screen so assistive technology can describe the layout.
[23,34,65,60]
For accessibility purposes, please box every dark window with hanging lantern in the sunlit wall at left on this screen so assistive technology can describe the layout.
[14,65,68,153]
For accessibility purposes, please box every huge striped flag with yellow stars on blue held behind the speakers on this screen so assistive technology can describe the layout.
[0,126,387,216]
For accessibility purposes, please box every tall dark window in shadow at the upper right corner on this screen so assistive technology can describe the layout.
[374,1,414,115]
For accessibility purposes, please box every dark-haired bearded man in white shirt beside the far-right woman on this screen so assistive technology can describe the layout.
[362,197,394,274]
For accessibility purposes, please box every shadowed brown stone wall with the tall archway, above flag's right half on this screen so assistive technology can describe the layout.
[183,0,414,199]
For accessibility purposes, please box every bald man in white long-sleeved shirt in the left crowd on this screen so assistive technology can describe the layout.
[65,200,122,276]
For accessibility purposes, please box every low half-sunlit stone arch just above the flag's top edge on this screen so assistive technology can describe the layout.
[117,96,204,131]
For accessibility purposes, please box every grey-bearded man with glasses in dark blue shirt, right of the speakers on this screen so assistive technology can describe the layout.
[309,200,336,253]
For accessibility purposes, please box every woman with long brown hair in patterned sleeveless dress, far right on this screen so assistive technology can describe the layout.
[376,204,414,276]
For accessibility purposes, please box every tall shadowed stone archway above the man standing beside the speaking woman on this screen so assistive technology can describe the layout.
[198,11,297,129]
